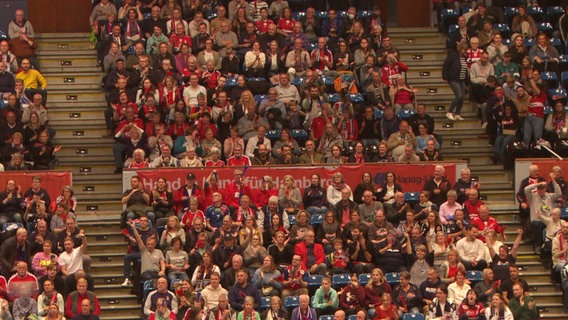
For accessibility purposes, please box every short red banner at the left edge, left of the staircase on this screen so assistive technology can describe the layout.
[0,171,72,200]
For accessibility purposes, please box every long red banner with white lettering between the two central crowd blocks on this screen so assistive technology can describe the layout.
[130,163,456,192]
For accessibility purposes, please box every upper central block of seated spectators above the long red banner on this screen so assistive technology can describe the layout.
[90,0,448,173]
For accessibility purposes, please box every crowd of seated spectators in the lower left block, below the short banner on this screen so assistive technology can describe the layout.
[0,176,100,320]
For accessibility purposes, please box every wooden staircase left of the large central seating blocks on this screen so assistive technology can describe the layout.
[37,33,140,320]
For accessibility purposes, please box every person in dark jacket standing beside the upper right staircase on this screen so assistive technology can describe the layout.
[442,42,467,120]
